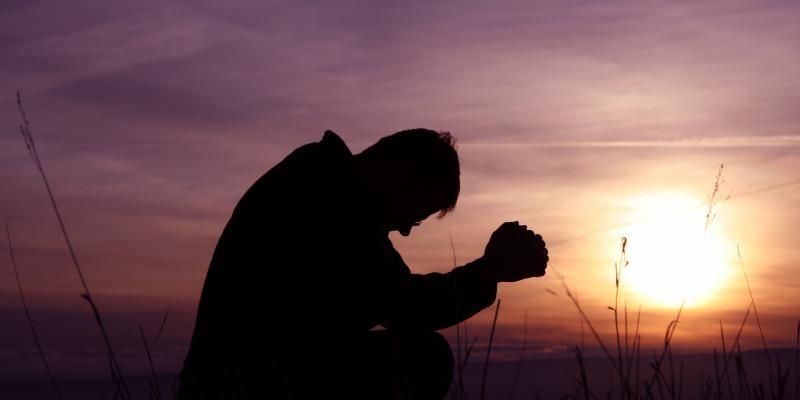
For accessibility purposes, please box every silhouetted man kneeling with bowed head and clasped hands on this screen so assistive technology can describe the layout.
[178,129,548,400]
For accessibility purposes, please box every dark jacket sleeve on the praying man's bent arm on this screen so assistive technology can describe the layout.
[304,227,497,331]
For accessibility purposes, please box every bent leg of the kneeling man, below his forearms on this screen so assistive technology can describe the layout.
[260,330,453,400]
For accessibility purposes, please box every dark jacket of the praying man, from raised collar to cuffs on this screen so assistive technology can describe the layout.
[179,131,496,399]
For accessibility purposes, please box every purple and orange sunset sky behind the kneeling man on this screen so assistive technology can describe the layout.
[0,0,800,379]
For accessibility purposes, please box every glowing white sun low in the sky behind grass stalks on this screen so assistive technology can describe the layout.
[617,193,736,308]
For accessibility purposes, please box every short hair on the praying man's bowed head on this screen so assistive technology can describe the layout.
[361,128,461,218]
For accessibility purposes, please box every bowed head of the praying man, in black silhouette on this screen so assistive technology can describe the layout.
[356,128,460,236]
